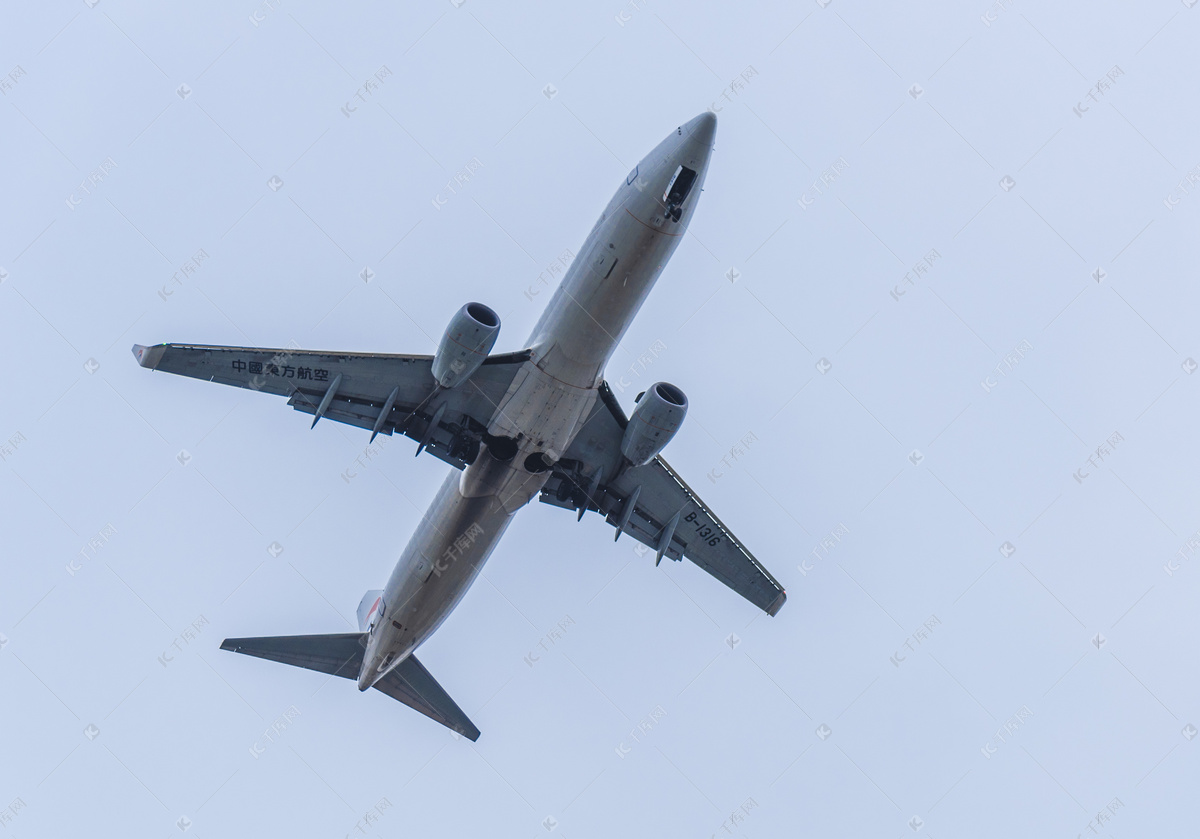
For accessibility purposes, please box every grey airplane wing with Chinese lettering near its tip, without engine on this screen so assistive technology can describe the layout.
[133,343,529,469]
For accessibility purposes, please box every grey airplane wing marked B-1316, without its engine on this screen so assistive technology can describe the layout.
[541,383,787,616]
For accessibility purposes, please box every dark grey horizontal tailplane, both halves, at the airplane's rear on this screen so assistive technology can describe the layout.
[221,638,479,741]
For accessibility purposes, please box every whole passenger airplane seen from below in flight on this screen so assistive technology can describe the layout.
[133,112,787,741]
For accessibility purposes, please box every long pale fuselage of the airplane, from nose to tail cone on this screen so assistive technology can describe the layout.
[359,113,716,690]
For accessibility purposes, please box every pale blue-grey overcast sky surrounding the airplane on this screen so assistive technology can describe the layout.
[0,0,1200,839]
